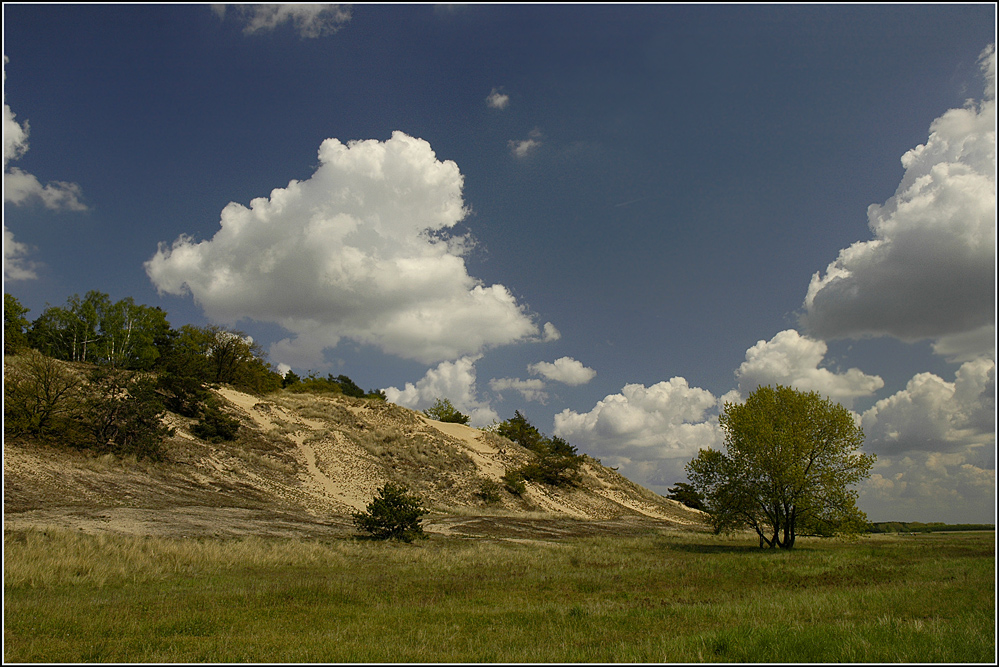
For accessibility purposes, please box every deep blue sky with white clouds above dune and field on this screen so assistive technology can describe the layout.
[3,4,996,521]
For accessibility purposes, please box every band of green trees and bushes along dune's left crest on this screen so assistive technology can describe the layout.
[4,291,385,460]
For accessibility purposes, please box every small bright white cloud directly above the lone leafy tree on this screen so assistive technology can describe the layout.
[735,329,884,408]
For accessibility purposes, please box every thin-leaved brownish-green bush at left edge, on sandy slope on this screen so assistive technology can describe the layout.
[3,350,81,436]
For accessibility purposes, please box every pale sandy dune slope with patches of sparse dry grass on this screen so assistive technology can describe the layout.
[4,380,703,539]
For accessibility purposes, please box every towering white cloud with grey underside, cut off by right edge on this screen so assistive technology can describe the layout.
[802,45,996,360]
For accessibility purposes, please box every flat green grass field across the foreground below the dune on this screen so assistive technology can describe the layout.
[4,530,996,663]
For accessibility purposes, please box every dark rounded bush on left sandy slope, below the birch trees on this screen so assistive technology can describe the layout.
[82,366,172,460]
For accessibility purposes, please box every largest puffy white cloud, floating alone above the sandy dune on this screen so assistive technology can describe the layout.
[145,132,539,367]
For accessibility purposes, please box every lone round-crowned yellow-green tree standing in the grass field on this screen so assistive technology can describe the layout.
[687,386,875,549]
